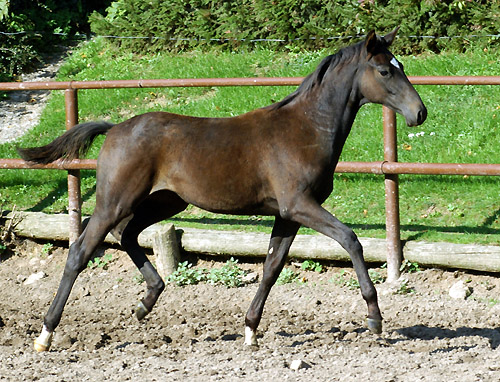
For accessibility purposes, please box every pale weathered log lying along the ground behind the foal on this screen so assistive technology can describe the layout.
[7,212,500,272]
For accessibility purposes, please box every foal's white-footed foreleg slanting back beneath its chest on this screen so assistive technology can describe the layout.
[245,216,300,346]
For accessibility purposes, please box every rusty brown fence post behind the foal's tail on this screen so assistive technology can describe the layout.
[64,89,82,245]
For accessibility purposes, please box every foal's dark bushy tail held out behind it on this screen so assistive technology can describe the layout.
[17,121,114,164]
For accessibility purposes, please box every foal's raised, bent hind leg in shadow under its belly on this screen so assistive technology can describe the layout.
[121,191,188,320]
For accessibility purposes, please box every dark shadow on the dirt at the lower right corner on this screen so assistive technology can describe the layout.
[387,325,500,351]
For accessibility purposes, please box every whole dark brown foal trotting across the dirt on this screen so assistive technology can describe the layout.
[20,30,427,351]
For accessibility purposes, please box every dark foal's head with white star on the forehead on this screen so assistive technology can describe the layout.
[359,28,427,126]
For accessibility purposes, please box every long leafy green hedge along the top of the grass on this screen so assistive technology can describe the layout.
[90,0,500,53]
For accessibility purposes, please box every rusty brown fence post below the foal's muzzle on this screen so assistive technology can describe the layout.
[382,106,403,282]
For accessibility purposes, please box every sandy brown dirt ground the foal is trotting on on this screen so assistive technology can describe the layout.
[0,241,500,382]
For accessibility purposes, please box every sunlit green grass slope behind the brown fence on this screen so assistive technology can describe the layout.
[0,40,500,244]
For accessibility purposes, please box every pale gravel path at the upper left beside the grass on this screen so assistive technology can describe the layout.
[0,49,68,143]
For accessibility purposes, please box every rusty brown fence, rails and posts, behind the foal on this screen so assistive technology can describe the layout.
[0,76,500,280]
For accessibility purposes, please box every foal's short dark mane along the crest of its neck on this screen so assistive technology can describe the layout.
[269,41,364,110]
